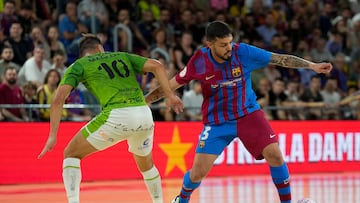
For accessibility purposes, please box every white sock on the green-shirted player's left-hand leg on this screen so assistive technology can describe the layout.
[62,158,81,203]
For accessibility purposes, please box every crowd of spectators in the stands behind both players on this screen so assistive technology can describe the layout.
[0,0,360,121]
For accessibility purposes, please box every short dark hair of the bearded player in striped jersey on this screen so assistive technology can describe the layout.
[205,21,232,41]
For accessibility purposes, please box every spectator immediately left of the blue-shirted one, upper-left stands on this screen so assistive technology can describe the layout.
[47,25,66,61]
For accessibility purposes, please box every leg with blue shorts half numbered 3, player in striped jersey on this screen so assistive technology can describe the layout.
[173,123,235,203]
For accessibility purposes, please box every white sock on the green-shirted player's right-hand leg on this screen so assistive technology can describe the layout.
[141,166,163,203]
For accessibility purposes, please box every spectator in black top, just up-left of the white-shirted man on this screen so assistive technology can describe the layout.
[4,22,33,66]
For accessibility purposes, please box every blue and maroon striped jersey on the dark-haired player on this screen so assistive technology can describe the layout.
[176,43,271,124]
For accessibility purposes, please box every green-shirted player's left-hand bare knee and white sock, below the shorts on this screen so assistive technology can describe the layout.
[62,132,97,203]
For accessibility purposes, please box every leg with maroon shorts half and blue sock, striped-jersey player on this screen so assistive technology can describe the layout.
[238,110,291,203]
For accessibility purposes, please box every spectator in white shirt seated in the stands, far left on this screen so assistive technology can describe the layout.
[19,46,51,87]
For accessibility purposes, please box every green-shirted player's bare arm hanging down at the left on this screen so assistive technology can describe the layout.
[38,85,73,158]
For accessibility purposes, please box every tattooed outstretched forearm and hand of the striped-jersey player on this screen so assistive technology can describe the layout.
[270,53,332,74]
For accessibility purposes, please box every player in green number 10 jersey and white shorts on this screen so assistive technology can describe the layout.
[38,35,183,203]
